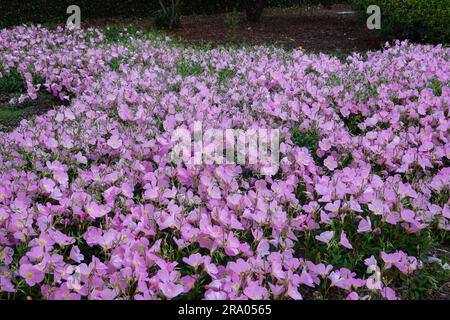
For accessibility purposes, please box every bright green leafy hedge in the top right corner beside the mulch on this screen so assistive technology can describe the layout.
[352,0,450,44]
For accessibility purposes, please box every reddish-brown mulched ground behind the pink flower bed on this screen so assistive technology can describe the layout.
[171,4,385,52]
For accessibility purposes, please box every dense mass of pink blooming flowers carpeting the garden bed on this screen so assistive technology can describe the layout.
[0,26,450,300]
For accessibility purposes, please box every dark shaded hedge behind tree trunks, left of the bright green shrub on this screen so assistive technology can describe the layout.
[0,0,348,28]
